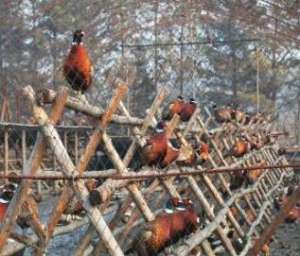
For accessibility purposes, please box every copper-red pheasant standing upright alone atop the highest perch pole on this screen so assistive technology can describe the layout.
[63,30,93,94]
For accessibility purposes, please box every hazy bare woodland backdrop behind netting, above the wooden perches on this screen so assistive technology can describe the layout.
[1,0,299,140]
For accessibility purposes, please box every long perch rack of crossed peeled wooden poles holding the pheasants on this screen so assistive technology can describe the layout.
[0,84,299,256]
